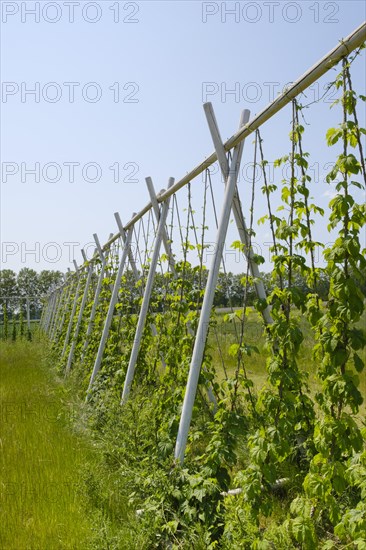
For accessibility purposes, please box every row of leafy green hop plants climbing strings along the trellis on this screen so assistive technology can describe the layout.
[46,52,366,550]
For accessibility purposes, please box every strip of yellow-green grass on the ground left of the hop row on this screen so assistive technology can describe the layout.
[0,342,98,550]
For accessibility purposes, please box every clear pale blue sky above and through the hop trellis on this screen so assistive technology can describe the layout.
[0,0,366,271]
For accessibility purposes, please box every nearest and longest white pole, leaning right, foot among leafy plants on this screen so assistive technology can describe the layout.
[175,110,250,463]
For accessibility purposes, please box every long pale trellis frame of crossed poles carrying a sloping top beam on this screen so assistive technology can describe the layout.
[41,24,366,468]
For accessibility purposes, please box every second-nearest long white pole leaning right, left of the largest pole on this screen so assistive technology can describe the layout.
[121,178,174,403]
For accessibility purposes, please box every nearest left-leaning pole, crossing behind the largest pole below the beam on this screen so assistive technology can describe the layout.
[203,103,273,324]
